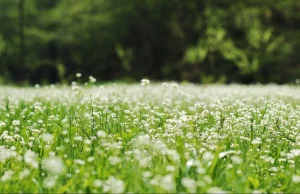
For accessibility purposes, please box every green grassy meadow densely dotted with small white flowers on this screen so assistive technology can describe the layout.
[0,80,300,193]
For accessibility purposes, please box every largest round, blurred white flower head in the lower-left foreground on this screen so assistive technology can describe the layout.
[43,156,65,174]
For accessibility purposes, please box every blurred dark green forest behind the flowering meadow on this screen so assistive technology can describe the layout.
[0,0,300,85]
